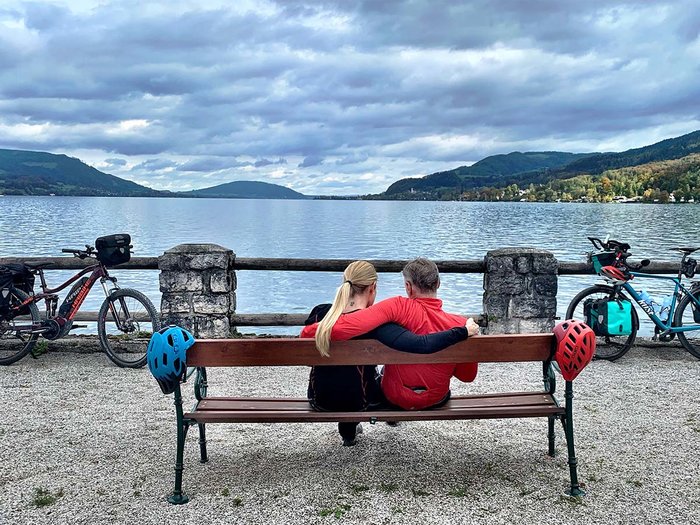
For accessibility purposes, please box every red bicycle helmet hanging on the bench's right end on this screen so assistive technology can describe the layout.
[554,319,595,381]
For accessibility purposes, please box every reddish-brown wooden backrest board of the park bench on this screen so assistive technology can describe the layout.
[187,333,554,367]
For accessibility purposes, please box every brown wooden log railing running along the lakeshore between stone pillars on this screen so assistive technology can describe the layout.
[0,257,678,326]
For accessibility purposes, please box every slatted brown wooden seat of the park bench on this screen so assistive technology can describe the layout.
[185,392,563,423]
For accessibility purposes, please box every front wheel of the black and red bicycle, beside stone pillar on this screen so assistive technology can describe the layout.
[97,288,160,368]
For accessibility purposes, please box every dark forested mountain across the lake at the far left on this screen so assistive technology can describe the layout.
[0,149,162,197]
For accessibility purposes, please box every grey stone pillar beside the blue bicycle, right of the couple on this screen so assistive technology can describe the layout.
[484,248,559,334]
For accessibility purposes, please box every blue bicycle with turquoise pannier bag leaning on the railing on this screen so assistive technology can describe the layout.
[566,237,700,361]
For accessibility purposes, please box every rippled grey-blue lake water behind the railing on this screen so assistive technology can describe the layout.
[0,196,700,333]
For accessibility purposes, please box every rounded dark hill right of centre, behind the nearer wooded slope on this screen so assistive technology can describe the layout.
[385,151,591,196]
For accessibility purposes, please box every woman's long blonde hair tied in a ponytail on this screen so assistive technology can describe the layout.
[315,261,377,357]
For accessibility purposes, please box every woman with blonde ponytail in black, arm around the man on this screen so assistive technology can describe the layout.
[300,261,468,446]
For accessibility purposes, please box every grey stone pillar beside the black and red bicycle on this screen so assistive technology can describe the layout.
[158,244,236,338]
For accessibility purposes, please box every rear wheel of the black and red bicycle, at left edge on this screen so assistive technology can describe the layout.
[0,288,41,365]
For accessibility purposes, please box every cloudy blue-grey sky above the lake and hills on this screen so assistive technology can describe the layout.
[0,0,700,195]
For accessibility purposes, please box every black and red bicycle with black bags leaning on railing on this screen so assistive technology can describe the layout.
[0,234,160,368]
